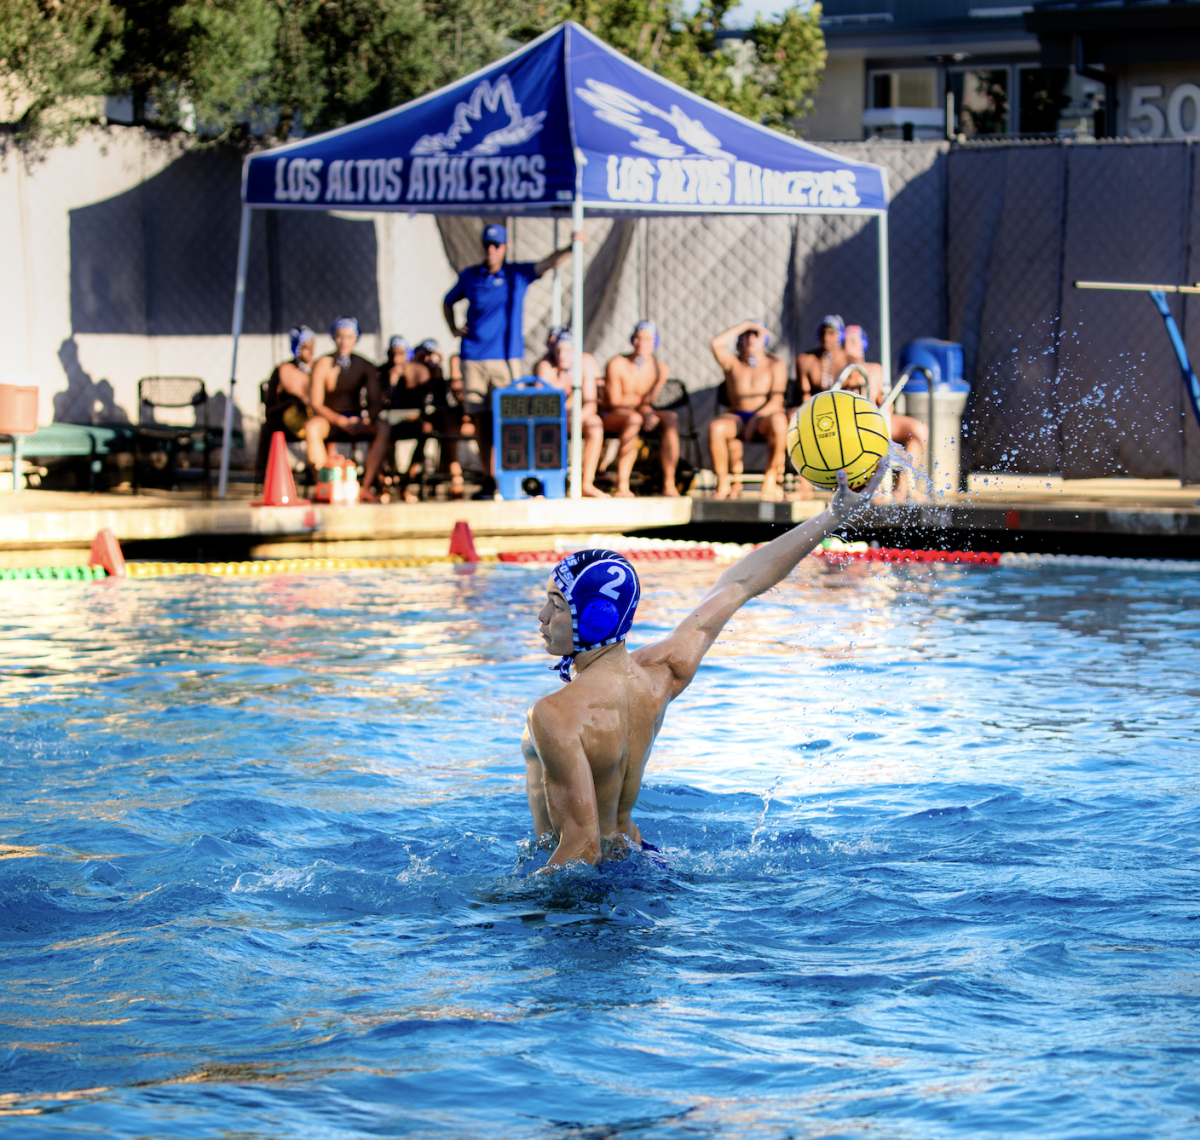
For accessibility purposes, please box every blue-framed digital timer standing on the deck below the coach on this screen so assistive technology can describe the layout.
[492,376,566,499]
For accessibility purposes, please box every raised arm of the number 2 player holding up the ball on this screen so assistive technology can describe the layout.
[637,462,887,698]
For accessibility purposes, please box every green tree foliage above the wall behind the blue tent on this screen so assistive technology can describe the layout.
[0,0,824,143]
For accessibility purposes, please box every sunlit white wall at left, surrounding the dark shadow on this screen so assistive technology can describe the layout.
[0,127,455,434]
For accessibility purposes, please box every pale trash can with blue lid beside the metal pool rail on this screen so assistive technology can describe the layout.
[896,336,971,494]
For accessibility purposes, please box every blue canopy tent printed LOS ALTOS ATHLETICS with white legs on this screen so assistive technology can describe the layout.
[220,22,892,497]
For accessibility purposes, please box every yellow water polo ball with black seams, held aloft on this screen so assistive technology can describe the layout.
[787,391,889,491]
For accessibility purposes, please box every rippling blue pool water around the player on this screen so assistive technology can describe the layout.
[0,563,1200,1140]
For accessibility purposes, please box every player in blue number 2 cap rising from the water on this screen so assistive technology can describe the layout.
[521,461,887,869]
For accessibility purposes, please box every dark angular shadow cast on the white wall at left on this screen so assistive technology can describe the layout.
[64,151,379,333]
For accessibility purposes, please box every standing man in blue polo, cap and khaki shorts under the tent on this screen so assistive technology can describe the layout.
[442,224,582,499]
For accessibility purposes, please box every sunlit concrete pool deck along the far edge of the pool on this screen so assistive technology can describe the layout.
[0,476,1200,566]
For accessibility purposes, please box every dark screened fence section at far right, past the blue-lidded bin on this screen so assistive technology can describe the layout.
[955,140,1200,480]
